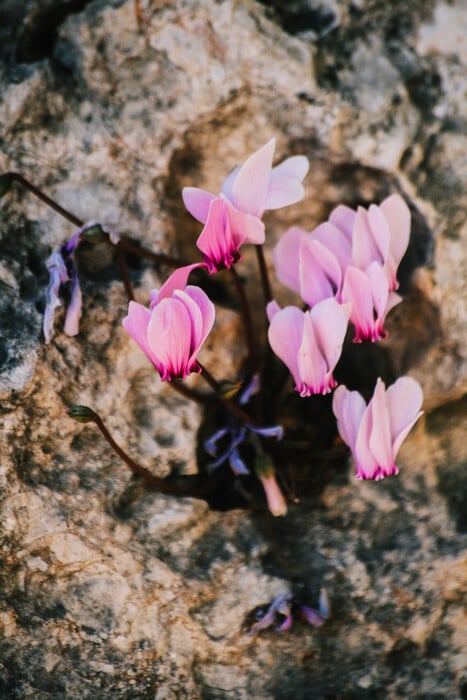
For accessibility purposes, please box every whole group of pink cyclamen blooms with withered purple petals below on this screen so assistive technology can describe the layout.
[119,139,422,514]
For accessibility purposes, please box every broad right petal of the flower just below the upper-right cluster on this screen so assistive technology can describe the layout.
[310,298,350,380]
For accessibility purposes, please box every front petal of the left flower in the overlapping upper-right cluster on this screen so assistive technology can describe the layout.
[299,235,342,306]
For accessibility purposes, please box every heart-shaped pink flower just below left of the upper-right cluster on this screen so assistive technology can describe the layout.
[268,298,350,396]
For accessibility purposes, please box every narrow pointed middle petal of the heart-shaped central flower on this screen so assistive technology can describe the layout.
[296,311,331,396]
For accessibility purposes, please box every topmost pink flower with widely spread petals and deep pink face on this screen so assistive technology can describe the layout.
[182,139,309,273]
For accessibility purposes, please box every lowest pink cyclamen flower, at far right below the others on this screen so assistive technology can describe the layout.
[332,377,423,479]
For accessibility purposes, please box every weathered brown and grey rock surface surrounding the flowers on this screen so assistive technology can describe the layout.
[0,0,467,700]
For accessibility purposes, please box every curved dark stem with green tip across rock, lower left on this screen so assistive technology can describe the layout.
[68,407,216,496]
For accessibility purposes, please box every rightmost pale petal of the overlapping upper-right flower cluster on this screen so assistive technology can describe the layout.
[380,194,410,291]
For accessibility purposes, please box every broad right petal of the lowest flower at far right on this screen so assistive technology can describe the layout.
[387,377,423,458]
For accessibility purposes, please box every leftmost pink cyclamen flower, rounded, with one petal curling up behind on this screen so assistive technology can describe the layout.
[122,265,215,381]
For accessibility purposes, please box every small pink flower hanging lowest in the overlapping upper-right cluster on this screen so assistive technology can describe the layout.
[341,261,402,343]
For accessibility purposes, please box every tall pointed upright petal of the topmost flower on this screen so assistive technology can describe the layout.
[231,139,276,218]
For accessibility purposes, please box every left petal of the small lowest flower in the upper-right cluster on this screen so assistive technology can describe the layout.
[342,266,374,343]
